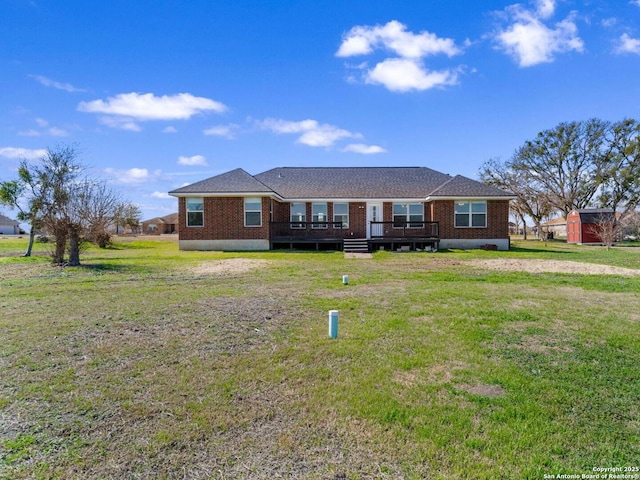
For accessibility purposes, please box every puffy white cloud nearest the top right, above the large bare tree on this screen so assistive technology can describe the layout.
[494,4,584,67]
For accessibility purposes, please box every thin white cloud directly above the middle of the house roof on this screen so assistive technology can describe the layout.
[259,118,362,147]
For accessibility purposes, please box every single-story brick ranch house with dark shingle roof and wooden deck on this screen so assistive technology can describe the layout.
[169,167,514,251]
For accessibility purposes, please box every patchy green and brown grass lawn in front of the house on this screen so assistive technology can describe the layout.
[0,237,640,479]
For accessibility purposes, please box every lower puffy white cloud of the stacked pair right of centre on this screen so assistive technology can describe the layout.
[365,58,458,92]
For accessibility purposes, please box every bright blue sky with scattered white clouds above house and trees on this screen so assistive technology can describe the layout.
[0,0,640,218]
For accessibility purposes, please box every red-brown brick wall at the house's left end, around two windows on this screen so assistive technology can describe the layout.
[178,197,270,240]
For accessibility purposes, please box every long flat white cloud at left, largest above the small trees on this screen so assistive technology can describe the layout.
[78,92,227,131]
